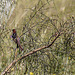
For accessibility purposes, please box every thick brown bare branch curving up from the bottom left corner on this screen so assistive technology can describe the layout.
[1,34,60,75]
